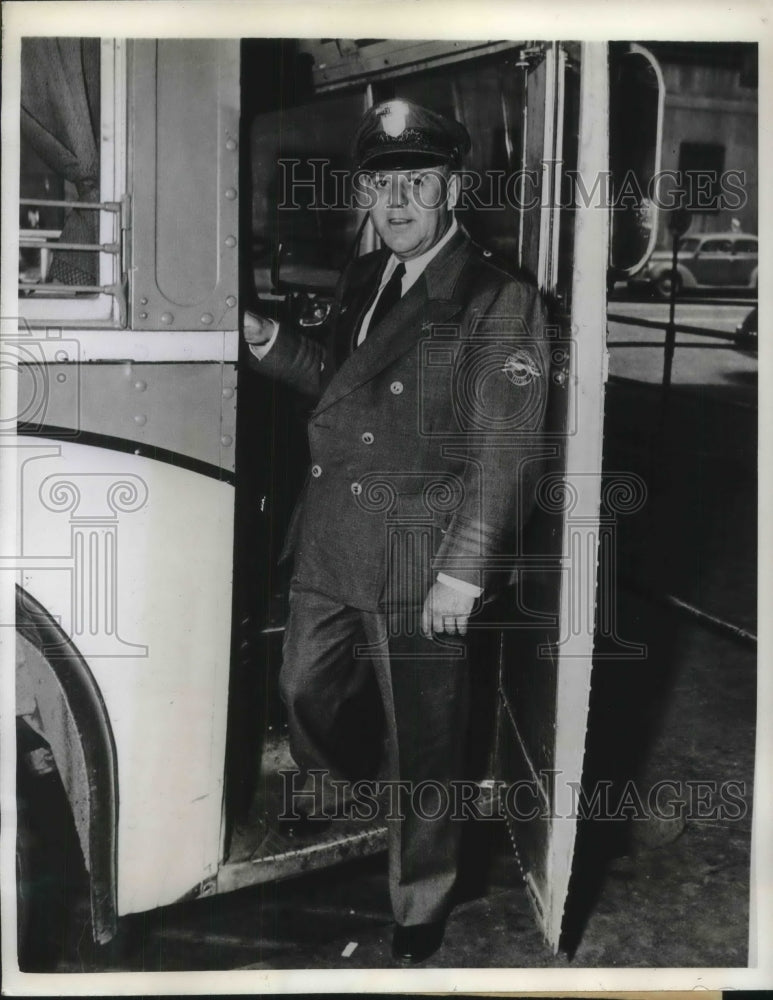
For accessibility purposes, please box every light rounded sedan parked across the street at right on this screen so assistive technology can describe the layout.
[628,233,758,299]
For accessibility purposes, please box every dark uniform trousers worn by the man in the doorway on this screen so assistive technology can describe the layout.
[280,581,469,926]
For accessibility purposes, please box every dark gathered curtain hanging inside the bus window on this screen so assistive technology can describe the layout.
[21,38,100,285]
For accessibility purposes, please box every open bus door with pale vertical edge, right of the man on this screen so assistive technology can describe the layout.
[494,43,608,951]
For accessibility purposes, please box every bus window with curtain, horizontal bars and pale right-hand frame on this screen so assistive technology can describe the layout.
[19,38,125,325]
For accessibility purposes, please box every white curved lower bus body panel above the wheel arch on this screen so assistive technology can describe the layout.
[19,437,233,915]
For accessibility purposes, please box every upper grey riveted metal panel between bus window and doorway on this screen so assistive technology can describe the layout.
[129,39,239,330]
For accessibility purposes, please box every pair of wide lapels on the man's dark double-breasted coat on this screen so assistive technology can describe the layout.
[314,230,470,414]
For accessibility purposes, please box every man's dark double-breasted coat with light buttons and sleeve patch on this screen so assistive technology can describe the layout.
[256,229,549,611]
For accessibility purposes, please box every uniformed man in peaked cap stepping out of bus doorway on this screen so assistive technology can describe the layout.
[244,100,548,962]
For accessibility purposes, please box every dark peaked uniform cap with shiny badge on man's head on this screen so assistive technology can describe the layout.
[354,98,471,170]
